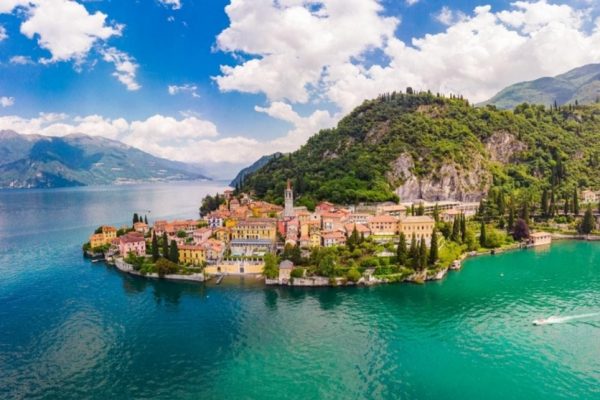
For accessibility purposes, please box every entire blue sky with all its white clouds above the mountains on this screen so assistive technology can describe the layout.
[0,0,600,174]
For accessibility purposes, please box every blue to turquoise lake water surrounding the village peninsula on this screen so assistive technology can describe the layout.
[0,183,600,399]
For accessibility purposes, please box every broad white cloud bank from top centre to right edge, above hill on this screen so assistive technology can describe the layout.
[215,0,600,113]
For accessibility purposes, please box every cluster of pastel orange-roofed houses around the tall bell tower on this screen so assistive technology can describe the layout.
[90,182,556,274]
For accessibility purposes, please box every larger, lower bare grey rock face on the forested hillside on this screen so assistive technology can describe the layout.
[388,153,492,201]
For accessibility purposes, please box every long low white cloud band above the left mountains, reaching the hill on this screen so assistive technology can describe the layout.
[0,103,335,165]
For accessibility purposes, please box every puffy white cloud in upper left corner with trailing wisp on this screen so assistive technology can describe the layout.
[0,0,140,90]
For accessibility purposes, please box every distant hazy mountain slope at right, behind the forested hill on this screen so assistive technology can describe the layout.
[480,64,600,109]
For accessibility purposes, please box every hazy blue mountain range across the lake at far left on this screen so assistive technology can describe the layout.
[0,131,208,188]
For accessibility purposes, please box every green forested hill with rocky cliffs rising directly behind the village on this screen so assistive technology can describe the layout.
[243,93,600,206]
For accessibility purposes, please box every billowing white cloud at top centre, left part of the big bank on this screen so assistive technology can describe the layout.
[215,0,398,103]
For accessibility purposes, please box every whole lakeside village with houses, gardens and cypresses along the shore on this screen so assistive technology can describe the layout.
[83,182,600,286]
